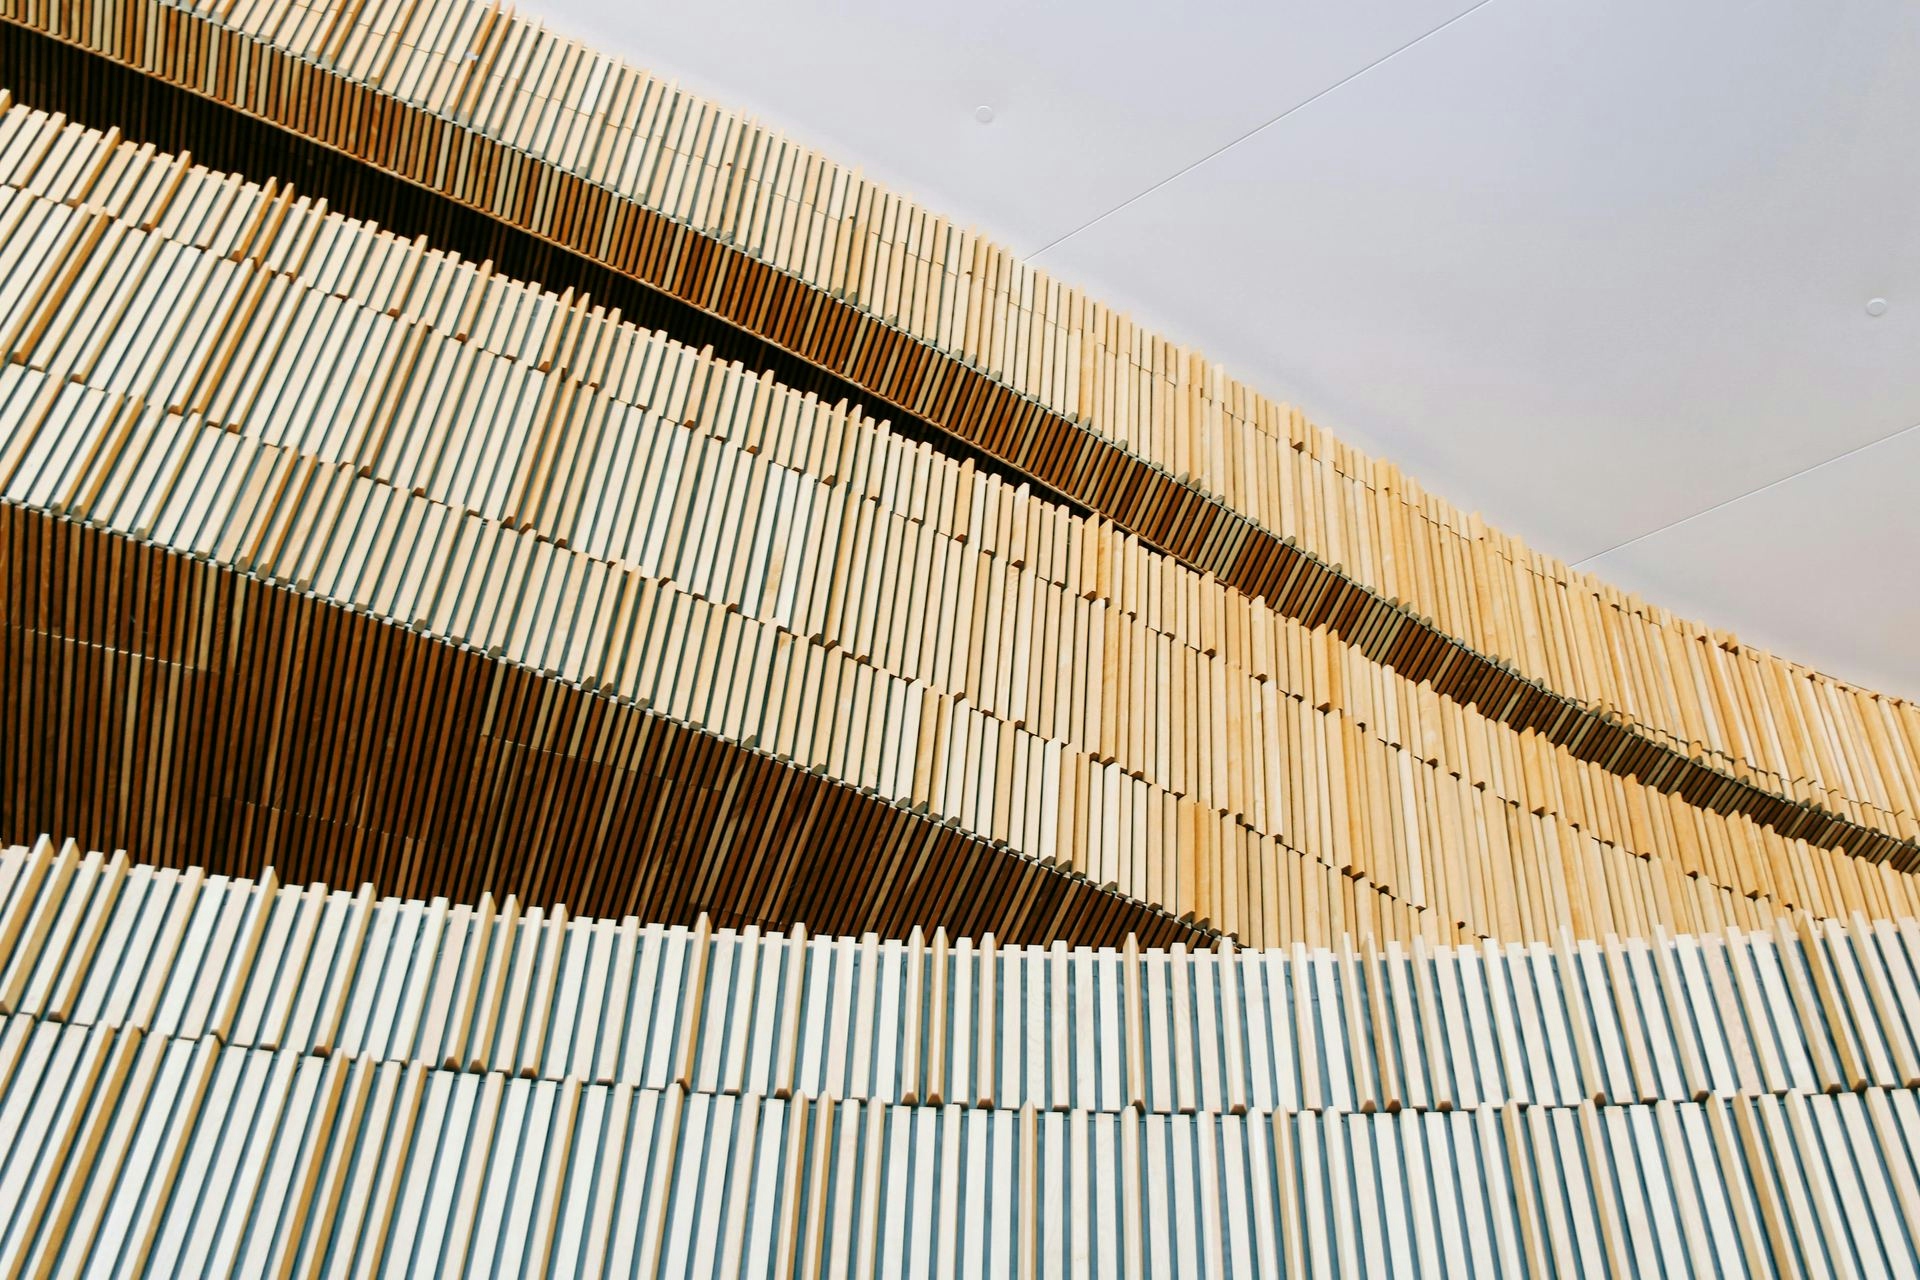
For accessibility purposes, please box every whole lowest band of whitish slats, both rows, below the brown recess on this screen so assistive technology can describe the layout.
[0,839,1920,1278]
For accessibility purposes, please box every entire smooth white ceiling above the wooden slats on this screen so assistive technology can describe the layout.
[526,0,1920,697]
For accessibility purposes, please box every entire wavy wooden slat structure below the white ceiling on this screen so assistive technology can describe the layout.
[0,0,1920,1276]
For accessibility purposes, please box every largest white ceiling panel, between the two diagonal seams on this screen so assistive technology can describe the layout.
[1041,0,1920,560]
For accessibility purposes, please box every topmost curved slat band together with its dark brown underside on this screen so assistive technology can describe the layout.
[0,4,1920,858]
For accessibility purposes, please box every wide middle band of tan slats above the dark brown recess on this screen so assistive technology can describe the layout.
[0,107,1916,944]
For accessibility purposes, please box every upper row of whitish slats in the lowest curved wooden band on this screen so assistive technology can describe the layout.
[0,839,1920,1113]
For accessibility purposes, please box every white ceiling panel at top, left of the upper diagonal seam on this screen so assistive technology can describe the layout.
[520,0,1475,253]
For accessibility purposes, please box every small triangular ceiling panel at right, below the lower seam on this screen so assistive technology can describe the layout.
[1580,426,1920,699]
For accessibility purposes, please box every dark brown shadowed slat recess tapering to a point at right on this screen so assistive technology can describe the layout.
[0,505,1198,940]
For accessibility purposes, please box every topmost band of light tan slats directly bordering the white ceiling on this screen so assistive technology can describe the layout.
[0,0,1920,839]
